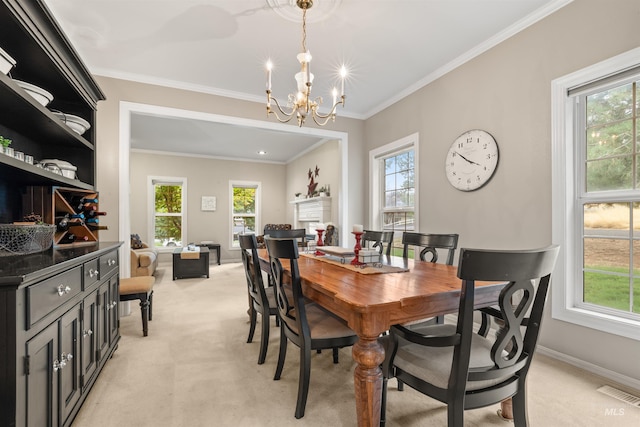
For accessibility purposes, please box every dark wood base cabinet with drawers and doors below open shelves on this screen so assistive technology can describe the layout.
[0,242,121,426]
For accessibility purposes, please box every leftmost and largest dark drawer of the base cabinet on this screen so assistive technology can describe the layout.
[27,266,82,326]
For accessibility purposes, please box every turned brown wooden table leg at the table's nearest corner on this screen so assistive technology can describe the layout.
[353,335,384,427]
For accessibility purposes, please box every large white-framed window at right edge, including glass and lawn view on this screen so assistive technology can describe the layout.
[552,49,640,339]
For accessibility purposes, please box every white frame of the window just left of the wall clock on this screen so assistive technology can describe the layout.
[369,132,420,237]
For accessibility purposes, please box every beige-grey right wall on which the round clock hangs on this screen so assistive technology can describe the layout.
[365,0,640,380]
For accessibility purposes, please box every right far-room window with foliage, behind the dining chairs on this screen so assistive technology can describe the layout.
[230,182,260,248]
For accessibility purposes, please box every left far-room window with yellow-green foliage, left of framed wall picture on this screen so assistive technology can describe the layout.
[149,177,187,248]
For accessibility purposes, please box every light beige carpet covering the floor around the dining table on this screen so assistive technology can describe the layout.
[73,264,640,427]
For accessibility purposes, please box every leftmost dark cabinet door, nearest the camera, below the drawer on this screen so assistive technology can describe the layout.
[26,322,60,427]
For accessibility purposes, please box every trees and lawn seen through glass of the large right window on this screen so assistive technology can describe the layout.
[579,80,640,315]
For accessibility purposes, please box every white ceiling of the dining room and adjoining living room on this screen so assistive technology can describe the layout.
[45,0,571,162]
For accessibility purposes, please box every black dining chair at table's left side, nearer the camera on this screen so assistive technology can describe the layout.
[265,237,358,418]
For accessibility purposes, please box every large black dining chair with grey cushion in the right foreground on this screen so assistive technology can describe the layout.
[381,245,559,427]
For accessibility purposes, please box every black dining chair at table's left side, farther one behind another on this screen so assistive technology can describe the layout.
[238,234,279,365]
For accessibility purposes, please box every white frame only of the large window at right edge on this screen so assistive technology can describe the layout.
[551,48,640,341]
